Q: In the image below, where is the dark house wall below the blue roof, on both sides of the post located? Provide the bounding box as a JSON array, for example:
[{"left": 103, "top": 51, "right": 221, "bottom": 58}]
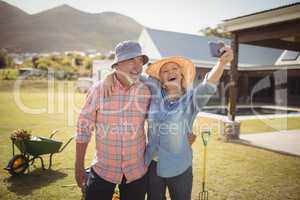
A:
[{"left": 194, "top": 68, "right": 300, "bottom": 107}]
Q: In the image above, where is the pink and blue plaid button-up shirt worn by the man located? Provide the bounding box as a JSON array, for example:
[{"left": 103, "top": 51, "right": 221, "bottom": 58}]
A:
[{"left": 76, "top": 79, "right": 151, "bottom": 184}]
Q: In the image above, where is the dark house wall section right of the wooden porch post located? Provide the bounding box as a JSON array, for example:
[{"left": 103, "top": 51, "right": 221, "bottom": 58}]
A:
[{"left": 238, "top": 69, "right": 300, "bottom": 107}]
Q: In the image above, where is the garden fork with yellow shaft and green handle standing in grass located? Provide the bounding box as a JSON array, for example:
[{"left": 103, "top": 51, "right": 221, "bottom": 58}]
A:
[{"left": 199, "top": 130, "right": 210, "bottom": 200}]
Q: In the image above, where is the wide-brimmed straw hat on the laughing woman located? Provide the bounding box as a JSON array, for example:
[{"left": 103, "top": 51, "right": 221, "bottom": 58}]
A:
[{"left": 146, "top": 56, "right": 196, "bottom": 88}]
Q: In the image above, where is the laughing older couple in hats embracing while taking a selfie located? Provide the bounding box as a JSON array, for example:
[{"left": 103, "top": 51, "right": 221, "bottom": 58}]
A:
[{"left": 75, "top": 41, "right": 233, "bottom": 200}]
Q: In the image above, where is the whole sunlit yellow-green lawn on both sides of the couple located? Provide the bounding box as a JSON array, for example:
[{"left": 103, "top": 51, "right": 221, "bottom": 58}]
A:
[{"left": 0, "top": 81, "right": 300, "bottom": 200}]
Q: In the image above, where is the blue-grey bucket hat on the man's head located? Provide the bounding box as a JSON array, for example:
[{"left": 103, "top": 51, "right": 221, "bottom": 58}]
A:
[{"left": 111, "top": 41, "right": 149, "bottom": 68}]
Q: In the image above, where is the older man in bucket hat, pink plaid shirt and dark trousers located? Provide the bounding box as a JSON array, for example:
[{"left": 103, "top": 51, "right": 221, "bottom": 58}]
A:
[{"left": 75, "top": 41, "right": 151, "bottom": 200}]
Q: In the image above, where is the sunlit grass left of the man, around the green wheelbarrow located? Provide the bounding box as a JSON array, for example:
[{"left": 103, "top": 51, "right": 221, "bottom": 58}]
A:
[{"left": 0, "top": 81, "right": 93, "bottom": 199}]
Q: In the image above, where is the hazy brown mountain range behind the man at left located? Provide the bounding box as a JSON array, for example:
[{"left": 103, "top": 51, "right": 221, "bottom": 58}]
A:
[{"left": 0, "top": 1, "right": 143, "bottom": 52}]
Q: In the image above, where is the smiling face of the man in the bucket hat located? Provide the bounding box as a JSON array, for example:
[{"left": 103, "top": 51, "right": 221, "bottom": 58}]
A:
[{"left": 116, "top": 56, "right": 143, "bottom": 82}]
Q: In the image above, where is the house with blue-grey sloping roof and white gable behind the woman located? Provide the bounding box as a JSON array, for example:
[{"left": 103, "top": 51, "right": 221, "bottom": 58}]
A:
[{"left": 139, "top": 28, "right": 300, "bottom": 105}]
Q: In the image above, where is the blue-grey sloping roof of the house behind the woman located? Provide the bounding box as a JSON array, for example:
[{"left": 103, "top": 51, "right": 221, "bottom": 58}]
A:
[{"left": 145, "top": 28, "right": 283, "bottom": 67}]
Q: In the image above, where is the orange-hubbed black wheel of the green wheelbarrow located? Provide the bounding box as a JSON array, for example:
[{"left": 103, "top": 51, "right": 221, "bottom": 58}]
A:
[{"left": 6, "top": 154, "right": 29, "bottom": 175}]
